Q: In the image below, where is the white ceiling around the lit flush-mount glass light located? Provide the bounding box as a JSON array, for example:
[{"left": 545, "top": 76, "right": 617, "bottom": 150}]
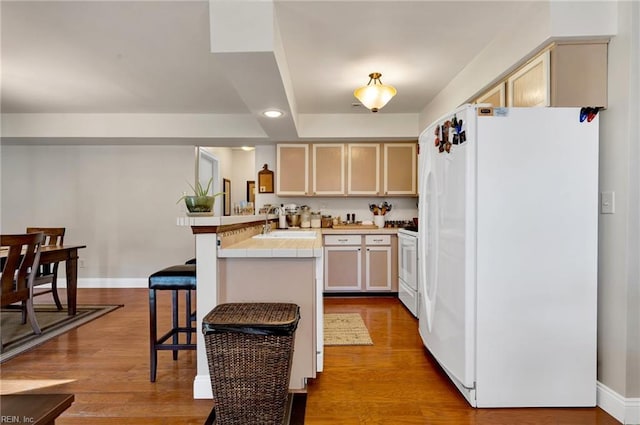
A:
[{"left": 0, "top": 0, "right": 530, "bottom": 142}]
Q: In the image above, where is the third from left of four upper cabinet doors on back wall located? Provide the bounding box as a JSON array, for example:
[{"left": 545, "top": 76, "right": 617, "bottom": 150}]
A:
[{"left": 347, "top": 143, "right": 380, "bottom": 195}]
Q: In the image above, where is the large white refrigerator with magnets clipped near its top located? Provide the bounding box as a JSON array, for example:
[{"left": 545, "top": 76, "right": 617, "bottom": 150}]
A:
[{"left": 418, "top": 105, "right": 598, "bottom": 407}]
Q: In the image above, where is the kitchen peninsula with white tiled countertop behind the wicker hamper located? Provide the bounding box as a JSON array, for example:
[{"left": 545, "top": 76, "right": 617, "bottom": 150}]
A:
[{"left": 185, "top": 215, "right": 323, "bottom": 398}]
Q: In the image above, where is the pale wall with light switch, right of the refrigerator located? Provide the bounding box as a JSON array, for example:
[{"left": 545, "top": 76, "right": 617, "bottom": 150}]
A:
[{"left": 598, "top": 2, "right": 640, "bottom": 408}]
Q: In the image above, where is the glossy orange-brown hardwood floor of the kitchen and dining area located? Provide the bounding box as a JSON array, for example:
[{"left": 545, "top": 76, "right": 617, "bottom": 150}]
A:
[{"left": 0, "top": 289, "right": 618, "bottom": 425}]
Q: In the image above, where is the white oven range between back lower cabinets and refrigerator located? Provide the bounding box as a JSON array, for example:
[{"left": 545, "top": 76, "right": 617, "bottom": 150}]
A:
[{"left": 398, "top": 229, "right": 418, "bottom": 317}]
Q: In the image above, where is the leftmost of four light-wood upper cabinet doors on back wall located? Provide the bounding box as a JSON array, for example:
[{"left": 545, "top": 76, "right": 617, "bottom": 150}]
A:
[{"left": 276, "top": 144, "right": 309, "bottom": 196}]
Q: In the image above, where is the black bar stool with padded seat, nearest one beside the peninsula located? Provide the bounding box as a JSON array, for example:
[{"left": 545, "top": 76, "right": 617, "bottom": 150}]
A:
[{"left": 149, "top": 264, "right": 196, "bottom": 382}]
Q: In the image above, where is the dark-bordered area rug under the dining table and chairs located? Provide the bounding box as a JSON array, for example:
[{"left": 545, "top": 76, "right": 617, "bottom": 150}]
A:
[{"left": 0, "top": 305, "right": 122, "bottom": 363}]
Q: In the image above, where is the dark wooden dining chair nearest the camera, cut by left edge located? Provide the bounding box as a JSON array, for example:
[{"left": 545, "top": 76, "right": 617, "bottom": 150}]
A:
[{"left": 0, "top": 233, "right": 44, "bottom": 335}]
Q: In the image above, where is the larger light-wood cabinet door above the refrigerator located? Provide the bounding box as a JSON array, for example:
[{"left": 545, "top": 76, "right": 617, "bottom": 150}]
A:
[{"left": 507, "top": 50, "right": 551, "bottom": 107}]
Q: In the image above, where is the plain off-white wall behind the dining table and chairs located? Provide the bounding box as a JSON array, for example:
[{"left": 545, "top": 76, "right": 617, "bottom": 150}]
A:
[{"left": 0, "top": 145, "right": 195, "bottom": 286}]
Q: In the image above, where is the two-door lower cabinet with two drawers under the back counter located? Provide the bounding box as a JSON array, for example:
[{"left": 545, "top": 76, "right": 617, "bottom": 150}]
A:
[{"left": 324, "top": 234, "right": 397, "bottom": 292}]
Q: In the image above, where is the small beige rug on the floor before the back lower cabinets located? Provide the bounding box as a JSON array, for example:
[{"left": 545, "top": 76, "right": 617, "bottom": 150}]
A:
[{"left": 324, "top": 313, "right": 373, "bottom": 345}]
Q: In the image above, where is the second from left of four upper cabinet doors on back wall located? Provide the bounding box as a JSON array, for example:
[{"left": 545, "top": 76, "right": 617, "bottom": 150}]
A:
[{"left": 311, "top": 143, "right": 345, "bottom": 195}]
